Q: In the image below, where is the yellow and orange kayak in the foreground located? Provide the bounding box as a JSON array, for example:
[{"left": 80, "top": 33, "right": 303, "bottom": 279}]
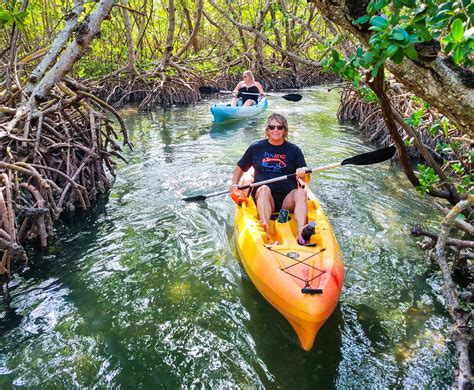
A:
[{"left": 234, "top": 173, "right": 344, "bottom": 351}]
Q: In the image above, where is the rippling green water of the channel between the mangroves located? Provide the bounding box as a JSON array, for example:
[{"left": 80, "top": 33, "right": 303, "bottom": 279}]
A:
[{"left": 0, "top": 88, "right": 454, "bottom": 389}]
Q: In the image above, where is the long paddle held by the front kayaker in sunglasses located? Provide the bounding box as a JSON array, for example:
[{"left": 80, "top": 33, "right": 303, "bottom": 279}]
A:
[{"left": 183, "top": 145, "right": 396, "bottom": 202}]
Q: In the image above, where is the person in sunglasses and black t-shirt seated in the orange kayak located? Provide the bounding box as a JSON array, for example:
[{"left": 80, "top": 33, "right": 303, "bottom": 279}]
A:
[{"left": 230, "top": 113, "right": 308, "bottom": 244}]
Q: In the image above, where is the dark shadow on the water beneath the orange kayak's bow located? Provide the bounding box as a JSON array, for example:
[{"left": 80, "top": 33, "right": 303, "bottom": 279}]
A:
[{"left": 240, "top": 270, "right": 343, "bottom": 389}]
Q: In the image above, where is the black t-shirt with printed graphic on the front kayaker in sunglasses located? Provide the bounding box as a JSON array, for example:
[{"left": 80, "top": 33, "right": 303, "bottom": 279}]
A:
[{"left": 237, "top": 139, "right": 306, "bottom": 195}]
